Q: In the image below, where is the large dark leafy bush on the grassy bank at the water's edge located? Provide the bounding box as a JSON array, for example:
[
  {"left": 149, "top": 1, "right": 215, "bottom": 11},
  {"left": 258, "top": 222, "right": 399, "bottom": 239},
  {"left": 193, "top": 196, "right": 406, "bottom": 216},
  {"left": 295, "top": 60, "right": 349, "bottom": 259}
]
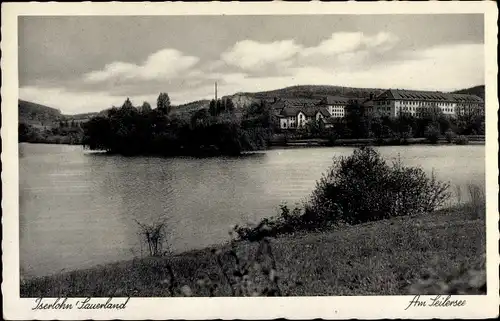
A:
[{"left": 304, "top": 147, "right": 449, "bottom": 225}]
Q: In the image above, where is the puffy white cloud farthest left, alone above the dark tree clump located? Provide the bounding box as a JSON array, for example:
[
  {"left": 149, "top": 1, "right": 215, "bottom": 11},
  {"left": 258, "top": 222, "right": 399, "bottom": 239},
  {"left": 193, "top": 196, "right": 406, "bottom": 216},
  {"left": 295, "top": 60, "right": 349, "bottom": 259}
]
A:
[{"left": 84, "top": 49, "right": 199, "bottom": 83}]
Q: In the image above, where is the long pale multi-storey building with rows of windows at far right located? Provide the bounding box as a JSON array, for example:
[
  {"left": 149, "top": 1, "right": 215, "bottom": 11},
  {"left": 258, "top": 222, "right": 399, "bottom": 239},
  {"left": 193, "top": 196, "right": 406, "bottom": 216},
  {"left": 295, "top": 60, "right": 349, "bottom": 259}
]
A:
[{"left": 373, "top": 89, "right": 484, "bottom": 117}]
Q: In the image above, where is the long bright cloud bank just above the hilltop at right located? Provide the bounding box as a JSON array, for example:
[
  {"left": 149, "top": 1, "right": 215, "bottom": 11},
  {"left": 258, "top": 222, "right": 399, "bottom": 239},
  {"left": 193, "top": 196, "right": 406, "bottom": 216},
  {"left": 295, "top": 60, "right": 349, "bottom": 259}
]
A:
[{"left": 284, "top": 44, "right": 484, "bottom": 91}]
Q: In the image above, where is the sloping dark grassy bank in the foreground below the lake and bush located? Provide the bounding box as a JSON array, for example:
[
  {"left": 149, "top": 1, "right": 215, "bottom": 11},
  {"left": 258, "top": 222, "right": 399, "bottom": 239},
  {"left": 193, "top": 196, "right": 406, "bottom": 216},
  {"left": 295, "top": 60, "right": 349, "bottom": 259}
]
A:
[{"left": 21, "top": 206, "right": 486, "bottom": 297}]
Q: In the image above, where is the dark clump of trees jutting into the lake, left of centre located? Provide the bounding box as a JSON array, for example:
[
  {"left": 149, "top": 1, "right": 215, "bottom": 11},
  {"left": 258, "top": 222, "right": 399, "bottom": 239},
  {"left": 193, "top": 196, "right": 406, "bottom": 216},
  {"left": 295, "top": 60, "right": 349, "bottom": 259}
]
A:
[{"left": 83, "top": 93, "right": 272, "bottom": 156}]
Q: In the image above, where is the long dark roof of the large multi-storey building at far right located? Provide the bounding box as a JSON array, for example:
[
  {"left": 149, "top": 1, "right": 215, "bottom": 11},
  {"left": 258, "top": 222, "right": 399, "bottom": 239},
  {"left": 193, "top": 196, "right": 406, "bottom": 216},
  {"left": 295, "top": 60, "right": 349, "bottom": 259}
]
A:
[{"left": 374, "top": 89, "right": 482, "bottom": 102}]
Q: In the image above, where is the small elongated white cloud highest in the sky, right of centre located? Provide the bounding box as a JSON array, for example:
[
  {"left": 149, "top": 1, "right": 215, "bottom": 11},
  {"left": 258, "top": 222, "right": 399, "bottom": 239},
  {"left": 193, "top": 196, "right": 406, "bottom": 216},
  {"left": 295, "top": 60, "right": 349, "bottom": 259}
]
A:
[{"left": 301, "top": 32, "right": 398, "bottom": 57}]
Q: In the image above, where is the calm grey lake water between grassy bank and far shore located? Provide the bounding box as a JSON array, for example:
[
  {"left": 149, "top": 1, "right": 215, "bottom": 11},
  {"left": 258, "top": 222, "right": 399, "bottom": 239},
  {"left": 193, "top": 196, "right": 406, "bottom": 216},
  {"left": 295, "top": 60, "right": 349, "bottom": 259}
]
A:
[{"left": 19, "top": 144, "right": 485, "bottom": 277}]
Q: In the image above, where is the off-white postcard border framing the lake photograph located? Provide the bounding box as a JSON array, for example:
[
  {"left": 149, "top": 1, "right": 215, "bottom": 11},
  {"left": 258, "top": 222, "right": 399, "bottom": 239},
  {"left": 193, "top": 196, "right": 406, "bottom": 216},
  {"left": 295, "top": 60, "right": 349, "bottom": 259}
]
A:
[{"left": 1, "top": 1, "right": 499, "bottom": 320}]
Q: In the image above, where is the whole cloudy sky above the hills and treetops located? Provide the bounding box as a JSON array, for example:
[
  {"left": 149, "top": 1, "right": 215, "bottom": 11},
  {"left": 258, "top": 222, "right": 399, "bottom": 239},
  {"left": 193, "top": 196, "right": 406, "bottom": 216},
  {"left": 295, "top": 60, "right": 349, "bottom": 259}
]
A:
[{"left": 18, "top": 14, "right": 485, "bottom": 114}]
